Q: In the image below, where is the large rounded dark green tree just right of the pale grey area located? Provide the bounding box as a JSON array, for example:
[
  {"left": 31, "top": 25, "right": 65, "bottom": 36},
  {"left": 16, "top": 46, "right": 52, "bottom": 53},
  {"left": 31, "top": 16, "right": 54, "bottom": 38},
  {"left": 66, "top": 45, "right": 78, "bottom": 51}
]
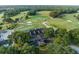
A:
[{"left": 10, "top": 31, "right": 31, "bottom": 44}]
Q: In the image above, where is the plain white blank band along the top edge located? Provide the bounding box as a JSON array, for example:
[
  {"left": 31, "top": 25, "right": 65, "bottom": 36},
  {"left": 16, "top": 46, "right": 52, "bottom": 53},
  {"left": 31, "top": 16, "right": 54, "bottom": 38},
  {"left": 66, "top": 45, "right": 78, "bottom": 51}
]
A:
[{"left": 0, "top": 0, "right": 79, "bottom": 5}]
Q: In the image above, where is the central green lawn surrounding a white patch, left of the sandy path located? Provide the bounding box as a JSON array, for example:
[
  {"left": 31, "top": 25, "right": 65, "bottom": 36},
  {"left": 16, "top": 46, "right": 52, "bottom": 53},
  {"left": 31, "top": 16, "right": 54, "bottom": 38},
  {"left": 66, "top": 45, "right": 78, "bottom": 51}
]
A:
[{"left": 15, "top": 16, "right": 48, "bottom": 31}]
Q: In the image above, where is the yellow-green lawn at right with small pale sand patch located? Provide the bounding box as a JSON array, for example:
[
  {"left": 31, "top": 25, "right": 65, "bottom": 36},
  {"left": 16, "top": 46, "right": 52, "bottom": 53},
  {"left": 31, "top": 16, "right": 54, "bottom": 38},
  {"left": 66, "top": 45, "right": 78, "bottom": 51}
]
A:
[{"left": 49, "top": 13, "right": 79, "bottom": 30}]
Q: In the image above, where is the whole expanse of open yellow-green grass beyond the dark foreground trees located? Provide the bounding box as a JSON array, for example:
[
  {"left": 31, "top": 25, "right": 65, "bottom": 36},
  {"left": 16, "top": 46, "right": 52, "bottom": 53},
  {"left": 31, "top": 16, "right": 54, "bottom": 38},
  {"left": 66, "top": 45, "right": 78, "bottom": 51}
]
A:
[{"left": 9, "top": 11, "right": 79, "bottom": 31}]
